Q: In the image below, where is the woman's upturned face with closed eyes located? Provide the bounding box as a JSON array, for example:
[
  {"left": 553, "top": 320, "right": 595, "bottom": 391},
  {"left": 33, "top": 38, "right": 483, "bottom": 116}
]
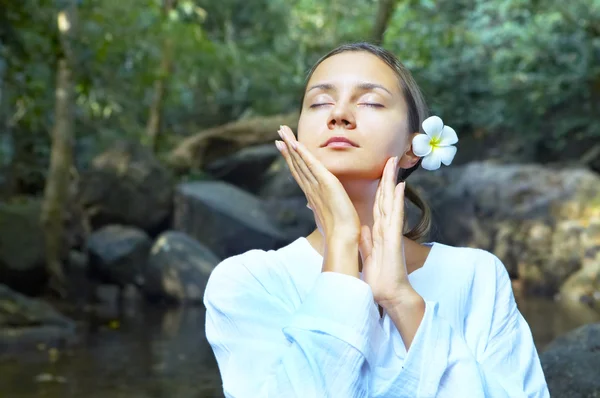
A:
[{"left": 298, "top": 52, "right": 416, "bottom": 179}]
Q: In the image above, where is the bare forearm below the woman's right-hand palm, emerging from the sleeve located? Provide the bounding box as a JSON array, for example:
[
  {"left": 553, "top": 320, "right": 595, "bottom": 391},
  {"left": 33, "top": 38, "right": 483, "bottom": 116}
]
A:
[{"left": 384, "top": 289, "right": 425, "bottom": 351}]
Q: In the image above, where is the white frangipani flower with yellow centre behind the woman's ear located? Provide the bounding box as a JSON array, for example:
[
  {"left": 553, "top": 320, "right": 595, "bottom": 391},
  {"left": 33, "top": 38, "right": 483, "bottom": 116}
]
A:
[{"left": 412, "top": 116, "right": 458, "bottom": 170}]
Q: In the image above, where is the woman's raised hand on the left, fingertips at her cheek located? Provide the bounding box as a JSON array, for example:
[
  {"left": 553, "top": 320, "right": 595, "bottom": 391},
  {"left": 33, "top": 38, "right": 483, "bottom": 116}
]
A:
[{"left": 275, "top": 126, "right": 360, "bottom": 244}]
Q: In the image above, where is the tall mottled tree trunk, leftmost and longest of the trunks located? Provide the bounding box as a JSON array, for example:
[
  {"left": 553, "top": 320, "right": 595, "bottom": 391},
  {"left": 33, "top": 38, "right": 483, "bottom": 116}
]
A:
[{"left": 41, "top": 3, "right": 75, "bottom": 296}]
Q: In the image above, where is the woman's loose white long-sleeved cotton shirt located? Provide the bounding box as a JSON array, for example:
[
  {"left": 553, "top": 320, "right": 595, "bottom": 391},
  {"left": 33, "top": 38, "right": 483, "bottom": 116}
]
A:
[{"left": 204, "top": 238, "right": 549, "bottom": 398}]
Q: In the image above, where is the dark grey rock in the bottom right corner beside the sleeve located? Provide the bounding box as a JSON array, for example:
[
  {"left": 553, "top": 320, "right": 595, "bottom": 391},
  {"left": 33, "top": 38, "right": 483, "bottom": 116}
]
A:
[{"left": 540, "top": 323, "right": 600, "bottom": 398}]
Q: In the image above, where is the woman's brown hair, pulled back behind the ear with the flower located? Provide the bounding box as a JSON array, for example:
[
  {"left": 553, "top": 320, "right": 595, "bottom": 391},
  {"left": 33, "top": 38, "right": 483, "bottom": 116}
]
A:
[{"left": 300, "top": 42, "right": 431, "bottom": 241}]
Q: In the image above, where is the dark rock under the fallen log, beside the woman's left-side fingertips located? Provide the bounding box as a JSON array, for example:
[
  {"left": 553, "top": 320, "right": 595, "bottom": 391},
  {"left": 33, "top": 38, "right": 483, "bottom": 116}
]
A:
[{"left": 205, "top": 144, "right": 281, "bottom": 194}]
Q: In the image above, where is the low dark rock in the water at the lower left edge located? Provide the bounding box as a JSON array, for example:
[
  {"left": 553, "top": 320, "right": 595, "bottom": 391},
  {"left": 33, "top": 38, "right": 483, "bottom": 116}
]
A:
[{"left": 0, "top": 285, "right": 76, "bottom": 358}]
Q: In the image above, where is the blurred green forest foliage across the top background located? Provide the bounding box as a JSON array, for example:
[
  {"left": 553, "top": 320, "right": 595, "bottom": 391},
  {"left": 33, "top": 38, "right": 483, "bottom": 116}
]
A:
[{"left": 0, "top": 0, "right": 600, "bottom": 193}]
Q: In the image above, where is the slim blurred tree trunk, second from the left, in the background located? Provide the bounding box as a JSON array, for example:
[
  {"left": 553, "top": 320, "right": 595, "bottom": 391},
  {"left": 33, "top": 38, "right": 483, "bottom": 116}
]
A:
[{"left": 146, "top": 0, "right": 177, "bottom": 152}]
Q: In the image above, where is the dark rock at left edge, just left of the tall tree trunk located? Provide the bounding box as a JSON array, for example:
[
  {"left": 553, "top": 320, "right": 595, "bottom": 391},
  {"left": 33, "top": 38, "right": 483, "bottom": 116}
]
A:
[{"left": 0, "top": 200, "right": 47, "bottom": 295}]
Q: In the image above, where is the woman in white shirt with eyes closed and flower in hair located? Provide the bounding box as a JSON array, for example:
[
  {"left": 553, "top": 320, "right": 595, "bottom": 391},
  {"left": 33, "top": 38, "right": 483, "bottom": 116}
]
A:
[{"left": 204, "top": 43, "right": 549, "bottom": 398}]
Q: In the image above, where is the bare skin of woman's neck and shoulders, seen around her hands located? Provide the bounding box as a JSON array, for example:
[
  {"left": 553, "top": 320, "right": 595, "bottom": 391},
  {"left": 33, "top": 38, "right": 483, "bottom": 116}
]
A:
[{"left": 307, "top": 180, "right": 431, "bottom": 273}]
